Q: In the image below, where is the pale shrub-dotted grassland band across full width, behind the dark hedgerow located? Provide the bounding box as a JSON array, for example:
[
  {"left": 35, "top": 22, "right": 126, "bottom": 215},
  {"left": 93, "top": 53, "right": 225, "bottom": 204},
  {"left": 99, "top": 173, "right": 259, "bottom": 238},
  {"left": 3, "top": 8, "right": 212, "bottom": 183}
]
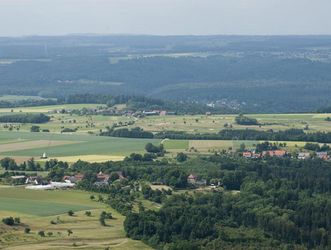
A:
[{"left": 0, "top": 104, "right": 331, "bottom": 134}]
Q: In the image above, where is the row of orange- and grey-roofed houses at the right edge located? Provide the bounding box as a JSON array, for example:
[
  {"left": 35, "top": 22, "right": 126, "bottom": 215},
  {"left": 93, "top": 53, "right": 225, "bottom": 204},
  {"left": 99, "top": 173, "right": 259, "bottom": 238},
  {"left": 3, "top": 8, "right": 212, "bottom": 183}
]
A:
[{"left": 242, "top": 149, "right": 331, "bottom": 160}]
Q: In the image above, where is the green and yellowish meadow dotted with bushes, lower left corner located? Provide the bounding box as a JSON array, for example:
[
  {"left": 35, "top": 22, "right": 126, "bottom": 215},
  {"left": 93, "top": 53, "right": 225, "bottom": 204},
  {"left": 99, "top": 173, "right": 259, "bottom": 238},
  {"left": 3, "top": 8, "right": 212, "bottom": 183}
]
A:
[{"left": 0, "top": 186, "right": 149, "bottom": 250}]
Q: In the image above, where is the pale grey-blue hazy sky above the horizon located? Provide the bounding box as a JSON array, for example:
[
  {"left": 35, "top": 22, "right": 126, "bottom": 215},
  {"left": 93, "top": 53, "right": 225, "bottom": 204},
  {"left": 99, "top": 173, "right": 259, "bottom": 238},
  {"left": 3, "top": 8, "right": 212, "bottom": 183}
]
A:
[{"left": 0, "top": 0, "right": 331, "bottom": 36}]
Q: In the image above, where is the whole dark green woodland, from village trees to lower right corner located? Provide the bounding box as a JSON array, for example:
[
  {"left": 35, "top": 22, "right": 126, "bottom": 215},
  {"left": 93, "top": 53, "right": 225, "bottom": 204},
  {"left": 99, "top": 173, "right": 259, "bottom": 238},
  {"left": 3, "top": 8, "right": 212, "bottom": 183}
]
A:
[{"left": 35, "top": 154, "right": 331, "bottom": 249}]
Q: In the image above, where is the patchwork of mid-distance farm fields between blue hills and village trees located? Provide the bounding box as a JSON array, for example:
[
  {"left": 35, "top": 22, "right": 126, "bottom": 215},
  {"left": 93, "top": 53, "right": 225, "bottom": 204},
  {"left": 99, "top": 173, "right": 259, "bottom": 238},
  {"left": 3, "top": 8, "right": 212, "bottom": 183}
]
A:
[{"left": 0, "top": 102, "right": 331, "bottom": 162}]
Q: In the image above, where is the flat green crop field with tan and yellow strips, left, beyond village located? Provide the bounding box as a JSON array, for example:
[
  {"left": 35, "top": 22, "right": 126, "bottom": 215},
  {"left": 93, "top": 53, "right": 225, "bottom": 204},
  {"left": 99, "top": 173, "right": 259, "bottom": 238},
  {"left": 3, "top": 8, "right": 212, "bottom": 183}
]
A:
[{"left": 0, "top": 131, "right": 160, "bottom": 161}]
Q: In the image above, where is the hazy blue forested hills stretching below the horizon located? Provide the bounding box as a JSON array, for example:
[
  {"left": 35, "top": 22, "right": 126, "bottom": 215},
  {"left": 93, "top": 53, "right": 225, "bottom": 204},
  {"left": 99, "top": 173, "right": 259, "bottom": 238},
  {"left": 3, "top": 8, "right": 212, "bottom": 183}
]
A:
[{"left": 0, "top": 36, "right": 331, "bottom": 112}]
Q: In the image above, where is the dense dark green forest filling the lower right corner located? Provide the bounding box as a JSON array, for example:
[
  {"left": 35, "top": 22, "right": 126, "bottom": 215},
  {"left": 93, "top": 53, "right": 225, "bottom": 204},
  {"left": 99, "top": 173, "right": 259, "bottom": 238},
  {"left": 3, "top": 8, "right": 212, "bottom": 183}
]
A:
[{"left": 124, "top": 156, "right": 331, "bottom": 249}]
